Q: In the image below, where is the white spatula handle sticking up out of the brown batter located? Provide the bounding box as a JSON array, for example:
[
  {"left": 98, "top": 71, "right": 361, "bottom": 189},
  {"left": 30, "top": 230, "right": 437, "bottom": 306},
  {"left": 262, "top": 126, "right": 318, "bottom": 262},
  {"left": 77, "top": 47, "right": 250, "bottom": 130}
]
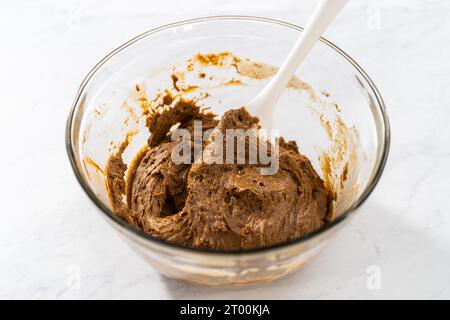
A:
[{"left": 246, "top": 0, "right": 349, "bottom": 129}]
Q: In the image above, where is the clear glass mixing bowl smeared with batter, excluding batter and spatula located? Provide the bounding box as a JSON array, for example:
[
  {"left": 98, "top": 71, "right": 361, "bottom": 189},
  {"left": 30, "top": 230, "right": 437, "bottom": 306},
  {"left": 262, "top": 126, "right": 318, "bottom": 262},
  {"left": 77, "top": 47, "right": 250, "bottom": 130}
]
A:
[{"left": 66, "top": 16, "right": 390, "bottom": 286}]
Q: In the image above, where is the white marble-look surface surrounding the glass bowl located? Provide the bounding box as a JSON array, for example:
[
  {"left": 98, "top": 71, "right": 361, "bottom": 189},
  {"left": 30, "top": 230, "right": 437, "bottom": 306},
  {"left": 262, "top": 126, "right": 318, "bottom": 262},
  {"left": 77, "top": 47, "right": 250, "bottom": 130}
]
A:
[{"left": 0, "top": 0, "right": 450, "bottom": 299}]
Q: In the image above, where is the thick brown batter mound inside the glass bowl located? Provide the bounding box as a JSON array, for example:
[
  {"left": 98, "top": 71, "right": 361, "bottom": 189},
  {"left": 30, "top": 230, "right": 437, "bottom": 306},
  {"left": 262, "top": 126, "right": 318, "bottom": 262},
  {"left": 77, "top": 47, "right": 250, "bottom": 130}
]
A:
[{"left": 106, "top": 95, "right": 330, "bottom": 250}]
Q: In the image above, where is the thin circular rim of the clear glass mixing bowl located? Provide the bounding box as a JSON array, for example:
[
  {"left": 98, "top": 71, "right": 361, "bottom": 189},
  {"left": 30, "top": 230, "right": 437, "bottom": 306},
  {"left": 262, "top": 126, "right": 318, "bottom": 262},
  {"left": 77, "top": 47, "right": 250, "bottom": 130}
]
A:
[{"left": 65, "top": 15, "right": 390, "bottom": 256}]
